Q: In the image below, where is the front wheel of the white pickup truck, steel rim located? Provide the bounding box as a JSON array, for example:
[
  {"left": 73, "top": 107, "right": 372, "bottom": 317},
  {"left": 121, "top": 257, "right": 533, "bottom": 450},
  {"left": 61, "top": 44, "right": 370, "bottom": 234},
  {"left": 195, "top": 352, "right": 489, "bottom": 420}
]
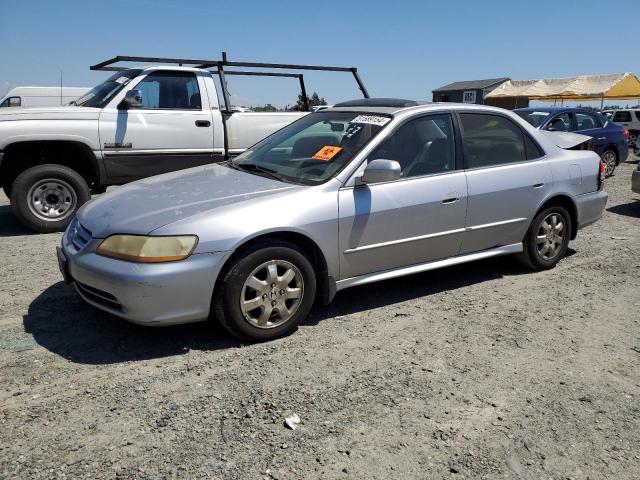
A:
[{"left": 11, "top": 164, "right": 91, "bottom": 233}]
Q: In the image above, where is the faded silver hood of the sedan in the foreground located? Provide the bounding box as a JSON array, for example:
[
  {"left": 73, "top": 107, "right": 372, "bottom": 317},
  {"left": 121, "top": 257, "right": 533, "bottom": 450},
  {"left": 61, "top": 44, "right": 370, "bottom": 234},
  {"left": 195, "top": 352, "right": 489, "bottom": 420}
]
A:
[{"left": 78, "top": 165, "right": 304, "bottom": 238}]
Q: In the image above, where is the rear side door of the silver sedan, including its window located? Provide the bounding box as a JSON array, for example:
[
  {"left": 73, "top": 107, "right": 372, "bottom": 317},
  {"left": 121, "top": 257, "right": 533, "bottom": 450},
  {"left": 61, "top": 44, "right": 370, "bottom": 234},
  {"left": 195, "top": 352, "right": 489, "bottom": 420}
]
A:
[{"left": 459, "top": 112, "right": 552, "bottom": 254}]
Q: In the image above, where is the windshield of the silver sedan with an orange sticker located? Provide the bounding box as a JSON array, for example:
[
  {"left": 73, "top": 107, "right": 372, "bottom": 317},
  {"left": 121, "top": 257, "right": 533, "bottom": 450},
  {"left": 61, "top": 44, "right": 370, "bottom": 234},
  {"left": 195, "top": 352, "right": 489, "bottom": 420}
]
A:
[{"left": 229, "top": 110, "right": 391, "bottom": 185}]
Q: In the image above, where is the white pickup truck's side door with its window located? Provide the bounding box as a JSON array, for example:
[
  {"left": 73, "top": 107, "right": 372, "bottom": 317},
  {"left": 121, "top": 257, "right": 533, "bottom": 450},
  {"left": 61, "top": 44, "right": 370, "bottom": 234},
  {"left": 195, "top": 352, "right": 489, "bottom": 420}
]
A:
[{"left": 99, "top": 70, "right": 216, "bottom": 181}]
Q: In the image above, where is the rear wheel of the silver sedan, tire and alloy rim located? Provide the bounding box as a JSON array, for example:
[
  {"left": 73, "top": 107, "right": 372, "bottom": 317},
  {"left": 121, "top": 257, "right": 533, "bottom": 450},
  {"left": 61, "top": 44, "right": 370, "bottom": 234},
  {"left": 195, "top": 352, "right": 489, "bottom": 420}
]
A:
[{"left": 517, "top": 206, "right": 571, "bottom": 271}]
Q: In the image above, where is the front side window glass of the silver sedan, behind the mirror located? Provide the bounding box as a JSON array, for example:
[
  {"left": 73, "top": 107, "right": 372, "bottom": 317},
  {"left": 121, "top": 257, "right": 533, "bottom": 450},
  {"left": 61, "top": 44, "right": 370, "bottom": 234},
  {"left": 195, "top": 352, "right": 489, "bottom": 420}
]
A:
[{"left": 369, "top": 114, "right": 455, "bottom": 178}]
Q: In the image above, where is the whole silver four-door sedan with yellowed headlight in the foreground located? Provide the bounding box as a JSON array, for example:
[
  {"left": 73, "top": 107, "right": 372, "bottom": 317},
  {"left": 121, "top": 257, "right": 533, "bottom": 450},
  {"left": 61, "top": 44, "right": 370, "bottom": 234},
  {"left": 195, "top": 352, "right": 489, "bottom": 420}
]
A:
[{"left": 58, "top": 99, "right": 607, "bottom": 340}]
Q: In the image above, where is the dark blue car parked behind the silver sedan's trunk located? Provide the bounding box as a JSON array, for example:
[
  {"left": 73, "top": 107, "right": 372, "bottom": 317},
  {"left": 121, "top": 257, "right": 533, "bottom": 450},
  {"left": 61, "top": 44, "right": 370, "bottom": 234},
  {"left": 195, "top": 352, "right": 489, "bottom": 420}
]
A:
[{"left": 514, "top": 107, "right": 629, "bottom": 176}]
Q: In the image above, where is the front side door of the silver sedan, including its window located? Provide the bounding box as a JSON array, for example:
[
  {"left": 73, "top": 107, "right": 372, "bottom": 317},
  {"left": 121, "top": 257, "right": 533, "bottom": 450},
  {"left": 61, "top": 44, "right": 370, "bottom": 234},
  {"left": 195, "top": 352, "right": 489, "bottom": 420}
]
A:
[{"left": 339, "top": 114, "right": 467, "bottom": 279}]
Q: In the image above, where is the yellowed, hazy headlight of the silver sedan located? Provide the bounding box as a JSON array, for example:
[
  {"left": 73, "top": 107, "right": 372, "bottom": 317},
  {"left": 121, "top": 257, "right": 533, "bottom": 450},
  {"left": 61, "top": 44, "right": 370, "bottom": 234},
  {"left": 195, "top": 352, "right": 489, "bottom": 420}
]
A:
[{"left": 96, "top": 235, "right": 198, "bottom": 263}]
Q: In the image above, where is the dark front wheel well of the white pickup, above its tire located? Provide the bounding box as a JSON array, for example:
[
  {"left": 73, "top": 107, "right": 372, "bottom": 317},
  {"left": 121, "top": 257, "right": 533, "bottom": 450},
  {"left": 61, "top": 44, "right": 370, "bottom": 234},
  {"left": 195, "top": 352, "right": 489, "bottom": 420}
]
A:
[{"left": 0, "top": 140, "right": 100, "bottom": 187}]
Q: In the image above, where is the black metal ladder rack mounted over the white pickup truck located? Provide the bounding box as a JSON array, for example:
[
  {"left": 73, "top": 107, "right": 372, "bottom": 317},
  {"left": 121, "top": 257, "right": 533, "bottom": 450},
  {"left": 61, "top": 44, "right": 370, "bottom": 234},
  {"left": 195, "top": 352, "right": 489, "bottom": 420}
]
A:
[{"left": 89, "top": 52, "right": 369, "bottom": 111}]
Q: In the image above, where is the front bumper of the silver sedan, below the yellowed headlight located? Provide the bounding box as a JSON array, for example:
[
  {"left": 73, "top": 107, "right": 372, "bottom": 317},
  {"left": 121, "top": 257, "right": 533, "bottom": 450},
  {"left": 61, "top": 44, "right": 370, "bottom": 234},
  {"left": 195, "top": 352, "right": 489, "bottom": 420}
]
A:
[{"left": 58, "top": 228, "right": 231, "bottom": 326}]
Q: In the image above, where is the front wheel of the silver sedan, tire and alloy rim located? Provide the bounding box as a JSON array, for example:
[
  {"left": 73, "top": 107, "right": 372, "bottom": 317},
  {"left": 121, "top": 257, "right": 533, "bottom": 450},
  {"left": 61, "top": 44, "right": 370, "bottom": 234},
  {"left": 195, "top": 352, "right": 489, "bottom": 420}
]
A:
[{"left": 212, "top": 240, "right": 316, "bottom": 342}]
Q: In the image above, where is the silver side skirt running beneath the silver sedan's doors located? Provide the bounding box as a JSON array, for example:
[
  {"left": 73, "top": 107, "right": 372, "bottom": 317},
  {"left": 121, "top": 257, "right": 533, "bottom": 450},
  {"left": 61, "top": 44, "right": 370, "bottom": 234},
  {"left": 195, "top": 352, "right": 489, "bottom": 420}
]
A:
[{"left": 336, "top": 243, "right": 523, "bottom": 291}]
